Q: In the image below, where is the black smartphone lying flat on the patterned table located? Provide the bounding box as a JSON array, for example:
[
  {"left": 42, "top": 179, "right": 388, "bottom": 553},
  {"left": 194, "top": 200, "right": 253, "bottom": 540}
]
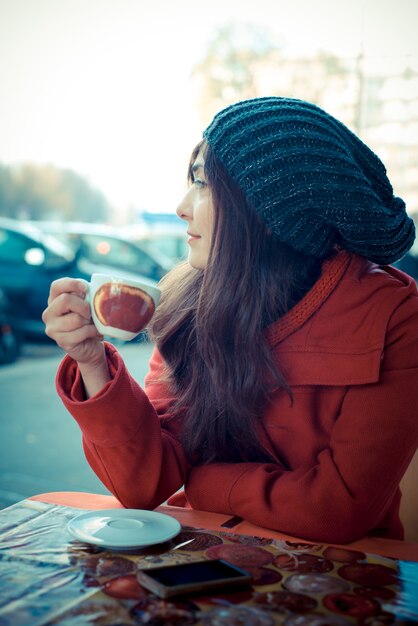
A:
[{"left": 136, "top": 559, "right": 251, "bottom": 598}]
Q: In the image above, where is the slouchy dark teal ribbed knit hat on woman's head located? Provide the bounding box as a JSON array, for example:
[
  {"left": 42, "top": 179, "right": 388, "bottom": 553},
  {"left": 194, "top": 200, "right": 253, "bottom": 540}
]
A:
[{"left": 203, "top": 97, "right": 415, "bottom": 264}]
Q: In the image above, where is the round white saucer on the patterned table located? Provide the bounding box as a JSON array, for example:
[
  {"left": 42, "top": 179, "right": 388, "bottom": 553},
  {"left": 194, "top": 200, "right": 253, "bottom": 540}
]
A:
[{"left": 67, "top": 509, "right": 181, "bottom": 550}]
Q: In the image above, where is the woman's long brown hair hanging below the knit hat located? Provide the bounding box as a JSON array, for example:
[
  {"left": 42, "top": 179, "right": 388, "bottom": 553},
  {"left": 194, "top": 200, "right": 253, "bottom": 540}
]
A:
[{"left": 149, "top": 142, "right": 321, "bottom": 464}]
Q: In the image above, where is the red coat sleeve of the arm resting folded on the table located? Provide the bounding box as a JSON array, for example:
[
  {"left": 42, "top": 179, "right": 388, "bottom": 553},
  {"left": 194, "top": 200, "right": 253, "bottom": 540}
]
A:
[{"left": 186, "top": 297, "right": 418, "bottom": 543}]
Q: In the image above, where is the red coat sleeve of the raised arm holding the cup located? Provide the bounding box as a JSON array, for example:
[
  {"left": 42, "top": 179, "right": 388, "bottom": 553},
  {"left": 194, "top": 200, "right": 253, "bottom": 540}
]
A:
[{"left": 57, "top": 344, "right": 188, "bottom": 509}]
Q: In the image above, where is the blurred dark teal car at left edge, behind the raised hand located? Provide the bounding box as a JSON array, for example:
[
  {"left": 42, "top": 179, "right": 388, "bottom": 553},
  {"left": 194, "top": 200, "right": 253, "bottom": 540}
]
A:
[{"left": 0, "top": 218, "right": 156, "bottom": 339}]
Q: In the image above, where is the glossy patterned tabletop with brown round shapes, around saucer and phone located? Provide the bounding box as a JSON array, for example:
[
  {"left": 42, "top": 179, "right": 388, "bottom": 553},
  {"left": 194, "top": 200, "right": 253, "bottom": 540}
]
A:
[{"left": 0, "top": 492, "right": 418, "bottom": 626}]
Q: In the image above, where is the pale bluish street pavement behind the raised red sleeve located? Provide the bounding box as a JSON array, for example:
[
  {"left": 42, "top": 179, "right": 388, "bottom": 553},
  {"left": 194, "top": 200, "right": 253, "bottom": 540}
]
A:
[{"left": 0, "top": 336, "right": 152, "bottom": 508}]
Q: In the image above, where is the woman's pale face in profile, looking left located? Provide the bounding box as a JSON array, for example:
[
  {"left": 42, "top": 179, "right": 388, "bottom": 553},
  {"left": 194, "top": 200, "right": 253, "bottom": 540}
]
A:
[{"left": 176, "top": 151, "right": 214, "bottom": 269}]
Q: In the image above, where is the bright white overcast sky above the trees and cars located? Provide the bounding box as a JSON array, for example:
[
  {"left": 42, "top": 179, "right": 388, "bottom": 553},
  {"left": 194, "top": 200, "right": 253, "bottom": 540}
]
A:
[{"left": 0, "top": 0, "right": 418, "bottom": 216}]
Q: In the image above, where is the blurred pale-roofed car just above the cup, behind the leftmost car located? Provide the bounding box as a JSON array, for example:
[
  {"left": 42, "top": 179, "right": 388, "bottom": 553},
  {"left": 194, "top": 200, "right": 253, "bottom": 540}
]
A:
[{"left": 31, "top": 221, "right": 173, "bottom": 282}]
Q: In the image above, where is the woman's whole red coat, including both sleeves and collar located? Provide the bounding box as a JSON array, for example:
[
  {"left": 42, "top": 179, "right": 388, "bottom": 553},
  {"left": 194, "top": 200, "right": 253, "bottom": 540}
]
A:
[{"left": 57, "top": 252, "right": 418, "bottom": 543}]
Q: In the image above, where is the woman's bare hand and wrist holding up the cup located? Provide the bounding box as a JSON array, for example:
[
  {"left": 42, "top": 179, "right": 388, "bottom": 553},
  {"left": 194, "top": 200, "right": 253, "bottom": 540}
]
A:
[{"left": 42, "top": 278, "right": 110, "bottom": 397}]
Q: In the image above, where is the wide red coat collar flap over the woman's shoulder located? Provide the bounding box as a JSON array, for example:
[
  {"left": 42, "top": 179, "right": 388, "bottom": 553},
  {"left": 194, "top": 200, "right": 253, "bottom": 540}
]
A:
[{"left": 266, "top": 246, "right": 415, "bottom": 386}]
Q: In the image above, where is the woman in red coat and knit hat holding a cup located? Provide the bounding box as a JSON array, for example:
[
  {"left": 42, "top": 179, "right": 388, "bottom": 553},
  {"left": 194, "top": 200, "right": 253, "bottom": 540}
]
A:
[{"left": 43, "top": 97, "right": 418, "bottom": 543}]
